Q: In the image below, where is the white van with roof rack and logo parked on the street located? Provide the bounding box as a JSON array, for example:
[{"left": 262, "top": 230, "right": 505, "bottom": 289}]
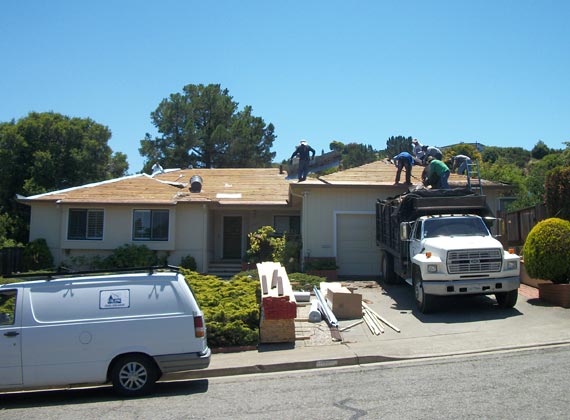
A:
[{"left": 0, "top": 271, "right": 211, "bottom": 396}]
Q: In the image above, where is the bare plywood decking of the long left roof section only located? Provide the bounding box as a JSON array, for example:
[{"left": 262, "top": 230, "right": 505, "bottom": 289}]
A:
[{"left": 22, "top": 168, "right": 290, "bottom": 205}]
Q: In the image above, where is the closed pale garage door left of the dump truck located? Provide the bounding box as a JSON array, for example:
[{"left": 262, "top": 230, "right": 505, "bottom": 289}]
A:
[{"left": 337, "top": 214, "right": 380, "bottom": 276}]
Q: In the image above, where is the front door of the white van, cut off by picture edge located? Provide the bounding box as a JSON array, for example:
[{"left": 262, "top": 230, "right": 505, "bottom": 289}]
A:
[{"left": 0, "top": 290, "right": 22, "bottom": 386}]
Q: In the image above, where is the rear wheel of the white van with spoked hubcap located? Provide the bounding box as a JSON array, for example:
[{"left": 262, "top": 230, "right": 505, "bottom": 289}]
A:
[{"left": 111, "top": 355, "right": 158, "bottom": 397}]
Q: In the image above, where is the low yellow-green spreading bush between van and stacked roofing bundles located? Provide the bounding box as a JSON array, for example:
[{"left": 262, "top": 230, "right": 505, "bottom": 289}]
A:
[{"left": 182, "top": 270, "right": 260, "bottom": 348}]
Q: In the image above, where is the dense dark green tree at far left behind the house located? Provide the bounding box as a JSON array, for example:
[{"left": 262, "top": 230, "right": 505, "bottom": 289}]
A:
[{"left": 0, "top": 112, "right": 128, "bottom": 242}]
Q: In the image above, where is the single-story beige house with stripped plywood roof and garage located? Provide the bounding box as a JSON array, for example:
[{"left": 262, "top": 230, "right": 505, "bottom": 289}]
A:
[{"left": 19, "top": 161, "right": 510, "bottom": 276}]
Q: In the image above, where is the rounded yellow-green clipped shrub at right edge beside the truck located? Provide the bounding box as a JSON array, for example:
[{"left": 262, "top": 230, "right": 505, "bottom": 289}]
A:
[{"left": 523, "top": 218, "right": 570, "bottom": 283}]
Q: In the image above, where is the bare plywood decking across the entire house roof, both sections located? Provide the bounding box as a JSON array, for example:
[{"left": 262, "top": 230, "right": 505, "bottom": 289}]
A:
[{"left": 20, "top": 161, "right": 504, "bottom": 206}]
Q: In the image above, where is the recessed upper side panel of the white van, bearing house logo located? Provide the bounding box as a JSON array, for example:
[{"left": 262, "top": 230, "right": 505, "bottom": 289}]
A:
[{"left": 30, "top": 279, "right": 184, "bottom": 323}]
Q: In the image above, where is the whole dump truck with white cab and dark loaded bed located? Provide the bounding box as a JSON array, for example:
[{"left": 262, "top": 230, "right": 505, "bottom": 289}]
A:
[{"left": 376, "top": 189, "right": 520, "bottom": 313}]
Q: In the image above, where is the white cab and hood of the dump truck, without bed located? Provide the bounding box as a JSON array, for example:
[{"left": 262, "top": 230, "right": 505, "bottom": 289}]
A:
[{"left": 404, "top": 214, "right": 520, "bottom": 310}]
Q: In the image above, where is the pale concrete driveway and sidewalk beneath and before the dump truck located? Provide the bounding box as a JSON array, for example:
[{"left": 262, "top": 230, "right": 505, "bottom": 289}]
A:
[{"left": 162, "top": 282, "right": 570, "bottom": 379}]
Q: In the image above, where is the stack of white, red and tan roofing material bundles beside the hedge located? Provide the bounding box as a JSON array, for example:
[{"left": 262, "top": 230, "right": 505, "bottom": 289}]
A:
[{"left": 257, "top": 262, "right": 297, "bottom": 343}]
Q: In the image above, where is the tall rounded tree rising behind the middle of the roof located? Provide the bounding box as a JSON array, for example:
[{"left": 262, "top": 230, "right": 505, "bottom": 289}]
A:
[{"left": 139, "top": 84, "right": 276, "bottom": 172}]
